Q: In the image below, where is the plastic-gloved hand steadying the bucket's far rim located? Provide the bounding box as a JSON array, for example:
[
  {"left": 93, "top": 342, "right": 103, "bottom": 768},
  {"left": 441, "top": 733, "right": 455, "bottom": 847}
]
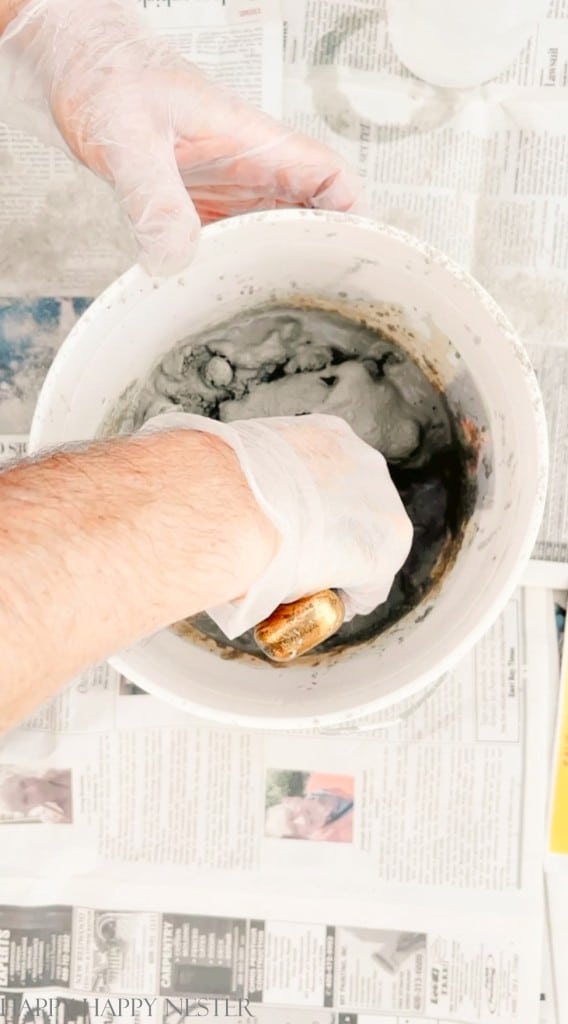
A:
[{"left": 0, "top": 0, "right": 360, "bottom": 273}]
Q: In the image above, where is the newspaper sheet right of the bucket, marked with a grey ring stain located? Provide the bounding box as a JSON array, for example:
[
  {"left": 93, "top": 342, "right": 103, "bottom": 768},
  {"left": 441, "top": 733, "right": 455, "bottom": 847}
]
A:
[{"left": 283, "top": 0, "right": 568, "bottom": 562}]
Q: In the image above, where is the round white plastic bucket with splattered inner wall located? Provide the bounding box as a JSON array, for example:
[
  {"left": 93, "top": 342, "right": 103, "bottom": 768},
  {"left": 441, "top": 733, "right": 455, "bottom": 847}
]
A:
[{"left": 31, "top": 210, "right": 547, "bottom": 729}]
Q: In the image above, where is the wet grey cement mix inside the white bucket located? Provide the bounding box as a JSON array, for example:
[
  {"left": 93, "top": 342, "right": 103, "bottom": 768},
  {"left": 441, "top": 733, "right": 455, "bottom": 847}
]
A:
[{"left": 108, "top": 307, "right": 472, "bottom": 656}]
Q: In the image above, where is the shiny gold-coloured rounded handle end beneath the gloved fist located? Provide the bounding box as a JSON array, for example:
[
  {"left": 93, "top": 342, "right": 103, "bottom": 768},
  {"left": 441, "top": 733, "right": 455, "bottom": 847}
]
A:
[{"left": 255, "top": 590, "right": 345, "bottom": 662}]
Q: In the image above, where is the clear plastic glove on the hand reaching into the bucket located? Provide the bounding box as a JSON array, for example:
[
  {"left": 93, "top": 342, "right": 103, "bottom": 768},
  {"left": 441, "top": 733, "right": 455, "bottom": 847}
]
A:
[{"left": 142, "top": 413, "right": 412, "bottom": 639}]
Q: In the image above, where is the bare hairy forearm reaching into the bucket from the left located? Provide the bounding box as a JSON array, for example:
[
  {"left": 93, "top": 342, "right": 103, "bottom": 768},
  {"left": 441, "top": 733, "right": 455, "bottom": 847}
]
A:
[{"left": 0, "top": 431, "right": 277, "bottom": 729}]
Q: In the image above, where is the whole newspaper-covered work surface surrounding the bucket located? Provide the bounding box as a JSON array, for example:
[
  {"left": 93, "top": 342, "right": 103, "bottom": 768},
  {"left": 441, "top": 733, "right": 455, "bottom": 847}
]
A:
[{"left": 0, "top": 0, "right": 568, "bottom": 1024}]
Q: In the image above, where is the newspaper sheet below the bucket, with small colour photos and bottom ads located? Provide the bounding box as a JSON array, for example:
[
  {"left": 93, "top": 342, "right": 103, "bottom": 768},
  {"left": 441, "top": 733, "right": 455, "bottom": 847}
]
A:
[{"left": 0, "top": 589, "right": 557, "bottom": 1024}]
